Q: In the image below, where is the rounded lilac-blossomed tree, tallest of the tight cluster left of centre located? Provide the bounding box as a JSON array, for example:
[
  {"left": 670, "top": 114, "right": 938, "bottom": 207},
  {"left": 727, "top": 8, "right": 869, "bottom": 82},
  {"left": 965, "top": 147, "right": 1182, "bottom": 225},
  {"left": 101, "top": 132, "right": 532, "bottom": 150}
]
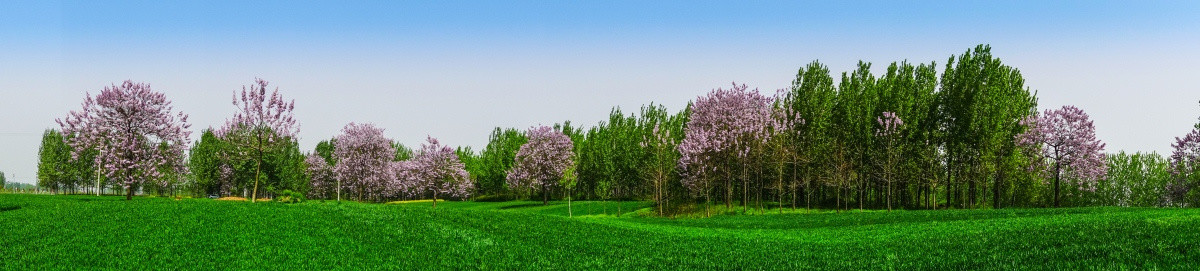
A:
[{"left": 334, "top": 122, "right": 396, "bottom": 201}]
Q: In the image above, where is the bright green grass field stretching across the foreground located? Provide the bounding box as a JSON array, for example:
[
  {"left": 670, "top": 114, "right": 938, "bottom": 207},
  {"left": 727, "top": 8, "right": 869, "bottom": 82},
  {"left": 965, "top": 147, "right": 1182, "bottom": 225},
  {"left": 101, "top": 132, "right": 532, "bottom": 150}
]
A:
[{"left": 0, "top": 194, "right": 1200, "bottom": 270}]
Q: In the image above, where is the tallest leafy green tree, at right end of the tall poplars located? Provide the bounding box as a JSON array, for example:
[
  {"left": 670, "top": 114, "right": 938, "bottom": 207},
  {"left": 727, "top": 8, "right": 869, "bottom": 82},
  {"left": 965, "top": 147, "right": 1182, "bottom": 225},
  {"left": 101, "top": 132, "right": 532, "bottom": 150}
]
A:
[{"left": 936, "top": 44, "right": 1037, "bottom": 207}]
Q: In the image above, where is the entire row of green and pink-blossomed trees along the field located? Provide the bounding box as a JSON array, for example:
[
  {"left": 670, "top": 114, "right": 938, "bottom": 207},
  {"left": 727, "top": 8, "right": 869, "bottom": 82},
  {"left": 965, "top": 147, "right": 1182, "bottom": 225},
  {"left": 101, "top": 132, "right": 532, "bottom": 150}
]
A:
[{"left": 38, "top": 46, "right": 1200, "bottom": 215}]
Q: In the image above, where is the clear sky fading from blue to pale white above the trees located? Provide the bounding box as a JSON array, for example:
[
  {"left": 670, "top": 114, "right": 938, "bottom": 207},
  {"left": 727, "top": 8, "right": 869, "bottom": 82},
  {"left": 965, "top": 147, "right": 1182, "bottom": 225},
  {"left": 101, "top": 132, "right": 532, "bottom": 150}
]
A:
[{"left": 0, "top": 0, "right": 1200, "bottom": 183}]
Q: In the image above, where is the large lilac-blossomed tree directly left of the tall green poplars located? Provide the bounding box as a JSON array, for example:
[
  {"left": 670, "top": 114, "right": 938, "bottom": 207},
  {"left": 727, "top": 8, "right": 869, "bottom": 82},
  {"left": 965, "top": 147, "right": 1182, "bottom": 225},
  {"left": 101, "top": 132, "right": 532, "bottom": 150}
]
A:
[{"left": 679, "top": 84, "right": 772, "bottom": 212}]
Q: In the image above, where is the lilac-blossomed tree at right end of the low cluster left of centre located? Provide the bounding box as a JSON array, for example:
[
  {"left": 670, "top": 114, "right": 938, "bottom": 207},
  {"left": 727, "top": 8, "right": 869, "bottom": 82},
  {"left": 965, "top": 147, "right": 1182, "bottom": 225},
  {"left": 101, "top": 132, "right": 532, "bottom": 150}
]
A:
[{"left": 410, "top": 137, "right": 475, "bottom": 207}]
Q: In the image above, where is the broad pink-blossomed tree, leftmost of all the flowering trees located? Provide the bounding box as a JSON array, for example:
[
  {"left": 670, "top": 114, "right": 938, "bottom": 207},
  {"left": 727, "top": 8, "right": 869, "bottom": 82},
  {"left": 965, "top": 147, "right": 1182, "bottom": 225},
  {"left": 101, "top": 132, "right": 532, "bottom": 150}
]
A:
[{"left": 55, "top": 80, "right": 191, "bottom": 199}]
